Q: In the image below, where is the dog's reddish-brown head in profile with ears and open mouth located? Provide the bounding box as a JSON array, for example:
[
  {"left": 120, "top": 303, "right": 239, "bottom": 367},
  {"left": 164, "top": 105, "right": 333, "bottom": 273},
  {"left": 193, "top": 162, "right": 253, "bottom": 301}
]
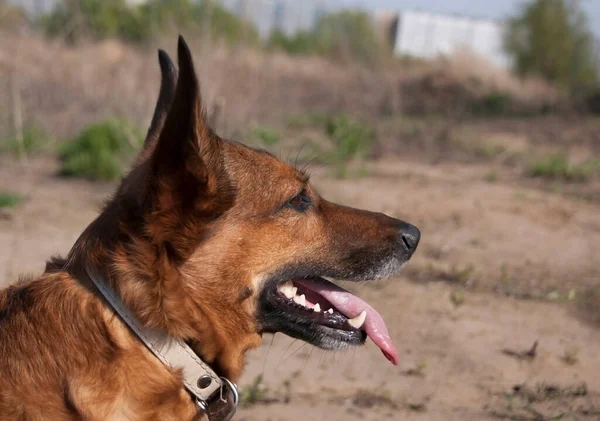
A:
[{"left": 75, "top": 38, "right": 420, "bottom": 378}]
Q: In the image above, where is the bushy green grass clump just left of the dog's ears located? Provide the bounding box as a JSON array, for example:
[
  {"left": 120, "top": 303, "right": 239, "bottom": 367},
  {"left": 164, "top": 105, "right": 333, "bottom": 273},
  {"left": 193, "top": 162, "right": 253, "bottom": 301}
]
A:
[{"left": 59, "top": 119, "right": 143, "bottom": 181}]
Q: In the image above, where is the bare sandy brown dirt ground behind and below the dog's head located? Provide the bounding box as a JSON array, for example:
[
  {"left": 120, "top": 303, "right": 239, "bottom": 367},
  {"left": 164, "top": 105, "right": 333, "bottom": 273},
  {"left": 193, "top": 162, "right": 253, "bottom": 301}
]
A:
[{"left": 0, "top": 151, "right": 600, "bottom": 421}]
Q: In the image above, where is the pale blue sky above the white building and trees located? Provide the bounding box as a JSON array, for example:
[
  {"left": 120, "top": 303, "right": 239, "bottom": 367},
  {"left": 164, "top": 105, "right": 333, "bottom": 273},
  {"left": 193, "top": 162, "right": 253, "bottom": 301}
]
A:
[{"left": 329, "top": 0, "right": 600, "bottom": 37}]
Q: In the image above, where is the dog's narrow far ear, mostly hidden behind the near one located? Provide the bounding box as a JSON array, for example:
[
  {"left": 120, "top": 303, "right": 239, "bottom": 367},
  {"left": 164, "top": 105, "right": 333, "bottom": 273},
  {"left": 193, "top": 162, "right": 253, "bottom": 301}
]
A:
[{"left": 144, "top": 50, "right": 177, "bottom": 148}]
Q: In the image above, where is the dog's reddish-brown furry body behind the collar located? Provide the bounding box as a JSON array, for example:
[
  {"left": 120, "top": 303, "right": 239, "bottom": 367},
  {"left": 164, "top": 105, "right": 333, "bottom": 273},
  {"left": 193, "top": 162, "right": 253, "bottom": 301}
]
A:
[{"left": 0, "top": 262, "right": 202, "bottom": 421}]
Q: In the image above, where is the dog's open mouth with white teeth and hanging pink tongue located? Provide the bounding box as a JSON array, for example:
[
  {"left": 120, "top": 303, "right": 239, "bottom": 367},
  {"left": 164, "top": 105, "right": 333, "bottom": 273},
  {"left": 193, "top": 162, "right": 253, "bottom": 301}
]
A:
[{"left": 262, "top": 277, "right": 399, "bottom": 365}]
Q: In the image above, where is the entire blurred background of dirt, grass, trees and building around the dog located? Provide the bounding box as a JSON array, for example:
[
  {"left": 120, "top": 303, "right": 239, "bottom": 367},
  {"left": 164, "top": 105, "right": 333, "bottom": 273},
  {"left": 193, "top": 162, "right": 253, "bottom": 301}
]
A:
[{"left": 0, "top": 0, "right": 600, "bottom": 421}]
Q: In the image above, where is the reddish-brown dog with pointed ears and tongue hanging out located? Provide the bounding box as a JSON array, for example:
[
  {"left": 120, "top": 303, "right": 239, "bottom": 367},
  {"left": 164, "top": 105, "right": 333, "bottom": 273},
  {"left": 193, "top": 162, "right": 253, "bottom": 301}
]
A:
[{"left": 0, "top": 38, "right": 420, "bottom": 421}]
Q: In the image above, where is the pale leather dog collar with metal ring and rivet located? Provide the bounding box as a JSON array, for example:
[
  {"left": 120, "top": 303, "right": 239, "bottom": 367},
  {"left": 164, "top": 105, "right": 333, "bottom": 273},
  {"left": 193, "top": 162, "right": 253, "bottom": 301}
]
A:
[{"left": 85, "top": 266, "right": 239, "bottom": 421}]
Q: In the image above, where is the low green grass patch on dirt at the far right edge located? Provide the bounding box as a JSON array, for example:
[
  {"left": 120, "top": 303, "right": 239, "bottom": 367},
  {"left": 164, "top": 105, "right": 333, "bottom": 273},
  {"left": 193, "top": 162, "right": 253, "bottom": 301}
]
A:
[{"left": 527, "top": 154, "right": 600, "bottom": 182}]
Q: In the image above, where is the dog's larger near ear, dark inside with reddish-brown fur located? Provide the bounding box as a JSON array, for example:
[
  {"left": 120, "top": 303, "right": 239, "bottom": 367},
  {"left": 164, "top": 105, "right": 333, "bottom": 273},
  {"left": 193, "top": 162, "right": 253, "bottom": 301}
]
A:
[{"left": 145, "top": 36, "right": 233, "bottom": 261}]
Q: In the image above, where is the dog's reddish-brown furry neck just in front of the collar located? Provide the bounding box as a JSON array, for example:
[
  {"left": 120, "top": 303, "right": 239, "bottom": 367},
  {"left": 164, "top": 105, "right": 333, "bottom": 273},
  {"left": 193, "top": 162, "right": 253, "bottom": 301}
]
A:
[{"left": 67, "top": 194, "right": 261, "bottom": 381}]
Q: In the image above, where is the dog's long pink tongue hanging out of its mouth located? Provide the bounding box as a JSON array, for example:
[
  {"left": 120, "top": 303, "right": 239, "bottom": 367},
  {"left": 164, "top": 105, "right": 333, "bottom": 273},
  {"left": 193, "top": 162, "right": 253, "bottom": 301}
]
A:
[{"left": 294, "top": 279, "right": 400, "bottom": 365}]
